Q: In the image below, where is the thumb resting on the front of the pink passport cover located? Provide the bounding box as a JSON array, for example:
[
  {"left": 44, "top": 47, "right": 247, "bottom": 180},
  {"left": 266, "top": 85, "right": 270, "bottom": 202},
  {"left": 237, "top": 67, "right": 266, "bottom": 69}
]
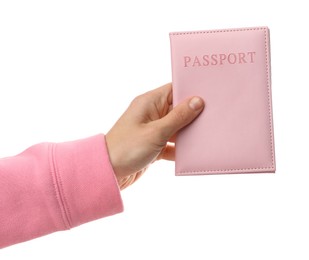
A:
[{"left": 158, "top": 97, "right": 205, "bottom": 140}]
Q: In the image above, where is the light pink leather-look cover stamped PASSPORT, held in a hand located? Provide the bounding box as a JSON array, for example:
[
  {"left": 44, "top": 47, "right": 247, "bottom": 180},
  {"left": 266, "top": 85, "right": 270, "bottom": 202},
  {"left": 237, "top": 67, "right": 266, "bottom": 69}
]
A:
[{"left": 170, "top": 27, "right": 275, "bottom": 175}]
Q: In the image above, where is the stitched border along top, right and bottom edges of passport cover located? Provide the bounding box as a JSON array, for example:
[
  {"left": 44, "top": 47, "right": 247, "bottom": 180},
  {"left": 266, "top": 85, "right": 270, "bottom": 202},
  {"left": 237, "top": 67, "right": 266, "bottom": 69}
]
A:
[{"left": 170, "top": 27, "right": 274, "bottom": 174}]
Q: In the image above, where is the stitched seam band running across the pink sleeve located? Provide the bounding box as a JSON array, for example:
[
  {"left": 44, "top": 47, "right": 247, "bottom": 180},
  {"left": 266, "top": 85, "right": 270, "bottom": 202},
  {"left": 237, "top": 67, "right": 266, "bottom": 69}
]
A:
[{"left": 50, "top": 144, "right": 71, "bottom": 229}]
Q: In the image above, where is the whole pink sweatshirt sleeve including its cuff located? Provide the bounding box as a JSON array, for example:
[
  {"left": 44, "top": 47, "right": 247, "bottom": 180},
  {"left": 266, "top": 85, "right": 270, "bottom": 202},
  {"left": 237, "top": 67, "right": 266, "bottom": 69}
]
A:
[{"left": 0, "top": 135, "right": 123, "bottom": 248}]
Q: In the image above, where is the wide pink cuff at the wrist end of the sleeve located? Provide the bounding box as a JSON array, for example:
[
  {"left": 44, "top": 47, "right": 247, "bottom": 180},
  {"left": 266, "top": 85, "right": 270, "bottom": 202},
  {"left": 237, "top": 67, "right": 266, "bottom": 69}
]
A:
[{"left": 50, "top": 134, "right": 123, "bottom": 229}]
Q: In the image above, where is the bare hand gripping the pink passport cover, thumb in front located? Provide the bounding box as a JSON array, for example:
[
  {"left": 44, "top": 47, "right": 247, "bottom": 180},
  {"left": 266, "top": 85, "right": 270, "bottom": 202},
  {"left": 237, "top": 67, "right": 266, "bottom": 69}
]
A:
[{"left": 106, "top": 84, "right": 204, "bottom": 189}]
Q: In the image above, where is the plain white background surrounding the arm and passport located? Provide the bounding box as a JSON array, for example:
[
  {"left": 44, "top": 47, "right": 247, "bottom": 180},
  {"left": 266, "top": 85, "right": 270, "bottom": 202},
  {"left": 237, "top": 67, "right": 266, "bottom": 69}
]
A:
[{"left": 0, "top": 0, "right": 309, "bottom": 260}]
